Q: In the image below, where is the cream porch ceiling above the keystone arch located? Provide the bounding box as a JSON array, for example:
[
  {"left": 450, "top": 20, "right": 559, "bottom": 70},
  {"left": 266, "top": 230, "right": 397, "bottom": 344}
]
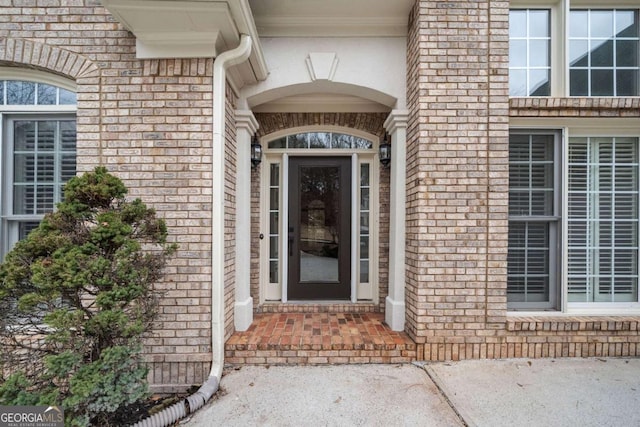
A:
[{"left": 249, "top": 0, "right": 415, "bottom": 37}]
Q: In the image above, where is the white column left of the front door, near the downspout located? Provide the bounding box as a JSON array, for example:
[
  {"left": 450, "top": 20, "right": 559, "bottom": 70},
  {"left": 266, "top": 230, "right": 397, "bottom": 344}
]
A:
[{"left": 233, "top": 110, "right": 258, "bottom": 331}]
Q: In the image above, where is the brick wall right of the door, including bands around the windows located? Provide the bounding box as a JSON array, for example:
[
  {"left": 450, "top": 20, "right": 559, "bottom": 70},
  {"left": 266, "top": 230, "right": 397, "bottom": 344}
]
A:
[{"left": 406, "top": 0, "right": 640, "bottom": 360}]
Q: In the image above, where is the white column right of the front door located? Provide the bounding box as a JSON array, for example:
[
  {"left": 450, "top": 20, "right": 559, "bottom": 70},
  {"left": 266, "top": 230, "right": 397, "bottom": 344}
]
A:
[{"left": 384, "top": 110, "right": 409, "bottom": 331}]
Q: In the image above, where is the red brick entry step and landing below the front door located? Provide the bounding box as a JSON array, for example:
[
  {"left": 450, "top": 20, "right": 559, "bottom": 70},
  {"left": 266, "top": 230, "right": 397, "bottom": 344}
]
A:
[{"left": 225, "top": 313, "right": 416, "bottom": 365}]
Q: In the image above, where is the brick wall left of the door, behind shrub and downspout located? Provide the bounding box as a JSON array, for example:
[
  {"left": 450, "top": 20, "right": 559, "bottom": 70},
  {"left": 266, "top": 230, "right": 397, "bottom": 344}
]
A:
[{"left": 0, "top": 0, "right": 226, "bottom": 390}]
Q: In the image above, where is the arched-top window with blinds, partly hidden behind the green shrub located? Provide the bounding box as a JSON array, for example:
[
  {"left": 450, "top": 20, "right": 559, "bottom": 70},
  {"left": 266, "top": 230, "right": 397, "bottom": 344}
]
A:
[{"left": 0, "top": 80, "right": 76, "bottom": 258}]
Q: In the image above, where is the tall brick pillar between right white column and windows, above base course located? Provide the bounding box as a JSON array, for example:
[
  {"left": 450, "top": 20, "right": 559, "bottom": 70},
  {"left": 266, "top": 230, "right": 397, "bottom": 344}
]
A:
[{"left": 406, "top": 0, "right": 508, "bottom": 343}]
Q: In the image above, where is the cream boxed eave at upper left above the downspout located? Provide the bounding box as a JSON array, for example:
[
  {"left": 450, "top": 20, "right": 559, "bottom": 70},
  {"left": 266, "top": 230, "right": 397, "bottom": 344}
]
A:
[{"left": 102, "top": 0, "right": 268, "bottom": 87}]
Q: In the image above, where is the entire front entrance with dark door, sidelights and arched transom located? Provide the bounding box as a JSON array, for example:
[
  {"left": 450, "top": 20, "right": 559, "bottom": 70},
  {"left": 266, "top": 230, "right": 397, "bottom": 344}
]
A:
[{"left": 260, "top": 126, "right": 380, "bottom": 303}]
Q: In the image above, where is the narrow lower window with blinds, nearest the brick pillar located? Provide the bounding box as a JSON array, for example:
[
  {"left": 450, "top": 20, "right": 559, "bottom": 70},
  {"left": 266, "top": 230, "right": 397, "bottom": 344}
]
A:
[{"left": 507, "top": 132, "right": 560, "bottom": 308}]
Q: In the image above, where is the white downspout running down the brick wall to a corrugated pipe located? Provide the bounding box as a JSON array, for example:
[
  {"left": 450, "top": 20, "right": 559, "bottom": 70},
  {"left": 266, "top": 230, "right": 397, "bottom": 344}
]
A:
[{"left": 134, "top": 34, "right": 252, "bottom": 427}]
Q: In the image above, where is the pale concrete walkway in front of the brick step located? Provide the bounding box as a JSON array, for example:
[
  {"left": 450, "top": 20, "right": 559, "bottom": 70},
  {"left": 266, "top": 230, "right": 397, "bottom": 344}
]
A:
[{"left": 181, "top": 358, "right": 640, "bottom": 427}]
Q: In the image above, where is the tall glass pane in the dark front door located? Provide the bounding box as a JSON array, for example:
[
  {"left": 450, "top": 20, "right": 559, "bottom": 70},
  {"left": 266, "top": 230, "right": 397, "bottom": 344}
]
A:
[{"left": 300, "top": 166, "right": 340, "bottom": 282}]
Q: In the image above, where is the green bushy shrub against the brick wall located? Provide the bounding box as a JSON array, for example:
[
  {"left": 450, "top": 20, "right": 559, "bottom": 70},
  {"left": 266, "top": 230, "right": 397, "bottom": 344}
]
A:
[{"left": 0, "top": 167, "right": 176, "bottom": 426}]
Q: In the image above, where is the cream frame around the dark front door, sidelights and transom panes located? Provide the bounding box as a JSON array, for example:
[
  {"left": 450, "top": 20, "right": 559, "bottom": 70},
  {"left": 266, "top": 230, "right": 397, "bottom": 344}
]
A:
[{"left": 256, "top": 126, "right": 380, "bottom": 304}]
